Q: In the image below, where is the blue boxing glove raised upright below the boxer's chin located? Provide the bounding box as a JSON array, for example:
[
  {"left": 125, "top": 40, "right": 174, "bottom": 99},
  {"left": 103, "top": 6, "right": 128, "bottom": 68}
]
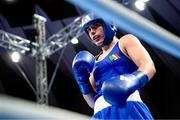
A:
[{"left": 72, "top": 51, "right": 95, "bottom": 94}]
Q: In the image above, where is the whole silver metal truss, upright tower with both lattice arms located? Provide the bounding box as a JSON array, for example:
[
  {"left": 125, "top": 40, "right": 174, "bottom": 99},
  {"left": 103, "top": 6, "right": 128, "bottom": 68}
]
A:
[{"left": 0, "top": 14, "right": 83, "bottom": 105}]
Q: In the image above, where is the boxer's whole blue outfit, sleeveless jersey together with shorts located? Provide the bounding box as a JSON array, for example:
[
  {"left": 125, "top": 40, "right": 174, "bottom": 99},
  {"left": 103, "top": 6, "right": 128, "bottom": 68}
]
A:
[{"left": 91, "top": 41, "right": 153, "bottom": 120}]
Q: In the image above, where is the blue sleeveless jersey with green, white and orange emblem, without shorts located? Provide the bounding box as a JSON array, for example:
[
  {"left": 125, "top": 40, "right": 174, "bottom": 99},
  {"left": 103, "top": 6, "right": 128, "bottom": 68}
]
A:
[{"left": 93, "top": 41, "right": 138, "bottom": 100}]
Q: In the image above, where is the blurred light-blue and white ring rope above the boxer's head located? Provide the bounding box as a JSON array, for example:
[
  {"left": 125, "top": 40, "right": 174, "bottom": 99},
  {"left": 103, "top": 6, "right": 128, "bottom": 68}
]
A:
[{"left": 68, "top": 0, "right": 180, "bottom": 58}]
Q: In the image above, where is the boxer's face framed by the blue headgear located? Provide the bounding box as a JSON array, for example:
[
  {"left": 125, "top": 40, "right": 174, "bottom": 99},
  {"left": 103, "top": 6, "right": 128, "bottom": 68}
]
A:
[{"left": 87, "top": 22, "right": 105, "bottom": 46}]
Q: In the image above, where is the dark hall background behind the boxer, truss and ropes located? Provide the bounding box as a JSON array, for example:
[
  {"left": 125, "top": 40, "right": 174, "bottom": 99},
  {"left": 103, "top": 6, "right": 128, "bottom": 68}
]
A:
[{"left": 0, "top": 0, "right": 180, "bottom": 119}]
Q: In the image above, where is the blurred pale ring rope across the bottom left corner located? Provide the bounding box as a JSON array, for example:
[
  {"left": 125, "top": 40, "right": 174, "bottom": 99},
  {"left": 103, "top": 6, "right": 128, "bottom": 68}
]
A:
[{"left": 0, "top": 95, "right": 90, "bottom": 120}]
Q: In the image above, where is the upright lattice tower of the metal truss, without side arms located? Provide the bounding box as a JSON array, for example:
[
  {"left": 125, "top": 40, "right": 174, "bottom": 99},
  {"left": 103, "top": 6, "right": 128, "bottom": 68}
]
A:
[{"left": 34, "top": 14, "right": 48, "bottom": 105}]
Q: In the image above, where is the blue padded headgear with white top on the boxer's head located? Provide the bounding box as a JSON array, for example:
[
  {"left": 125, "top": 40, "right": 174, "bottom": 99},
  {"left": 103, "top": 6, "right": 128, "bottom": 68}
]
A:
[{"left": 81, "top": 14, "right": 115, "bottom": 46}]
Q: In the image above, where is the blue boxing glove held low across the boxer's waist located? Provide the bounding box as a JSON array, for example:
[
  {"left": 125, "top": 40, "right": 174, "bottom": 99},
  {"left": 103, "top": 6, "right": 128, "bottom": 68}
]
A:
[{"left": 101, "top": 71, "right": 148, "bottom": 107}]
